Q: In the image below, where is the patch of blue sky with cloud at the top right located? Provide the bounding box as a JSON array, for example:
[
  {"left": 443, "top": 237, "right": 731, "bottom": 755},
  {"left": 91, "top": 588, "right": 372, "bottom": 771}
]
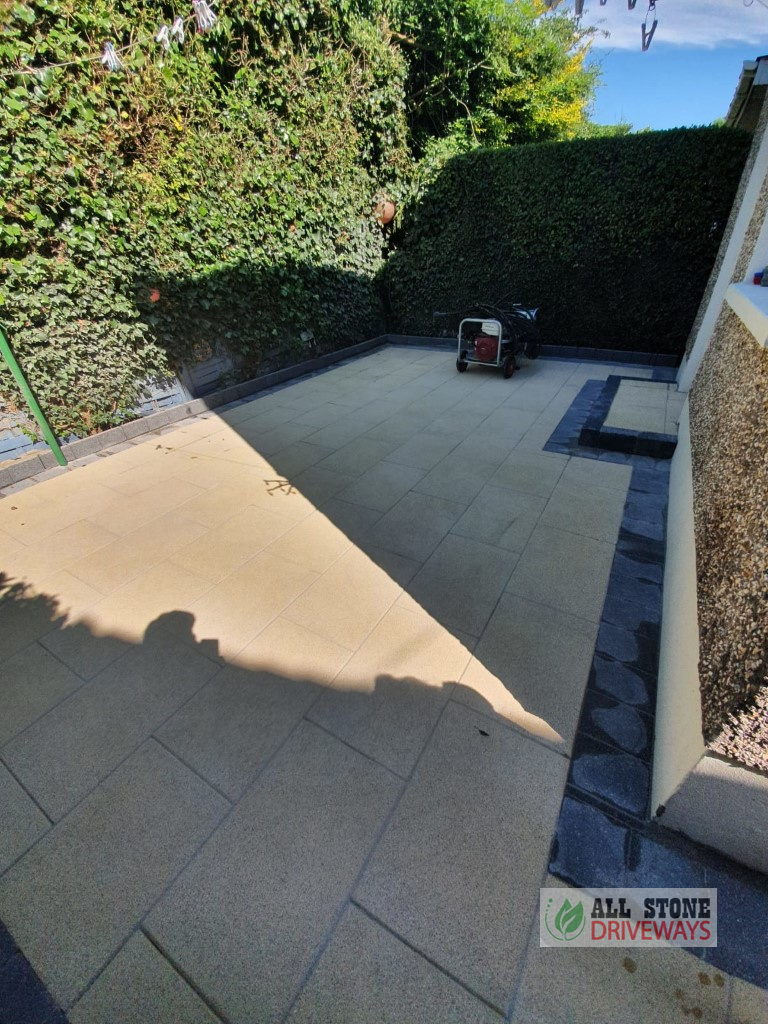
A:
[{"left": 584, "top": 0, "right": 768, "bottom": 129}]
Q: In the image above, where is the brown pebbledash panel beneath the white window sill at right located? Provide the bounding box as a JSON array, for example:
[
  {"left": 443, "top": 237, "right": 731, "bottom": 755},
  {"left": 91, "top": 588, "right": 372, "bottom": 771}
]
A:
[{"left": 689, "top": 306, "right": 768, "bottom": 771}]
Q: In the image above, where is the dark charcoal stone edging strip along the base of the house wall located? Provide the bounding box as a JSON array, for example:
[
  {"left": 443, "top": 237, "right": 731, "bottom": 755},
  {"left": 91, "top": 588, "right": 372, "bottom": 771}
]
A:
[{"left": 545, "top": 369, "right": 768, "bottom": 988}]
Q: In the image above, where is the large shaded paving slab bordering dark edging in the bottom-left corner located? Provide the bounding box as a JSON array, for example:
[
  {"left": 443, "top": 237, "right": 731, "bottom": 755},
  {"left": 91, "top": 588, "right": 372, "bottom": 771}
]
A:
[{"left": 0, "top": 741, "right": 229, "bottom": 1006}]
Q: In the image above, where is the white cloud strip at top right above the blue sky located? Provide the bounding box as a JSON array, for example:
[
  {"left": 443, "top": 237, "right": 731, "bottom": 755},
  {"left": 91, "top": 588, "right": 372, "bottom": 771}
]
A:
[{"left": 583, "top": 0, "right": 768, "bottom": 50}]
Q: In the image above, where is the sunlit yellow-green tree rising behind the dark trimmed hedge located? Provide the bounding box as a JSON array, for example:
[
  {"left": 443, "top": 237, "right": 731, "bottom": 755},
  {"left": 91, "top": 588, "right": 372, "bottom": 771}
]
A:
[{"left": 385, "top": 0, "right": 599, "bottom": 151}]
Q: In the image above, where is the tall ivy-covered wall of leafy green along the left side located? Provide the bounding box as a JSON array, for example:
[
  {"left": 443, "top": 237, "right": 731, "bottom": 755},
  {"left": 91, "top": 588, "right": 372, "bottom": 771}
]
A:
[{"left": 0, "top": 0, "right": 410, "bottom": 436}]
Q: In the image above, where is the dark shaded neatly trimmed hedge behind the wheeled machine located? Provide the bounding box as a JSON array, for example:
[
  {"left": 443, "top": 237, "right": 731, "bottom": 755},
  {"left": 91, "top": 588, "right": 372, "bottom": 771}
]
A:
[{"left": 386, "top": 128, "right": 751, "bottom": 354}]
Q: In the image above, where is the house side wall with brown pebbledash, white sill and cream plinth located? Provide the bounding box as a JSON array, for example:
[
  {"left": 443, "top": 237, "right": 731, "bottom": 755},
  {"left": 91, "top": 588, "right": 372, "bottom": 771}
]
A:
[{"left": 652, "top": 61, "right": 768, "bottom": 872}]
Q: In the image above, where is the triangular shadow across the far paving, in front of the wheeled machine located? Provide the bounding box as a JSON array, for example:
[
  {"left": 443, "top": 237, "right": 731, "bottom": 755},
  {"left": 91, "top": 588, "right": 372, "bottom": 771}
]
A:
[{"left": 191, "top": 352, "right": 606, "bottom": 753}]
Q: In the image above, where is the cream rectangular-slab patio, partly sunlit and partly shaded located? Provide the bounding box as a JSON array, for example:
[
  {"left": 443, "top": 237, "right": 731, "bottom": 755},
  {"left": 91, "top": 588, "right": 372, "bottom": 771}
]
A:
[{"left": 0, "top": 348, "right": 768, "bottom": 1024}]
